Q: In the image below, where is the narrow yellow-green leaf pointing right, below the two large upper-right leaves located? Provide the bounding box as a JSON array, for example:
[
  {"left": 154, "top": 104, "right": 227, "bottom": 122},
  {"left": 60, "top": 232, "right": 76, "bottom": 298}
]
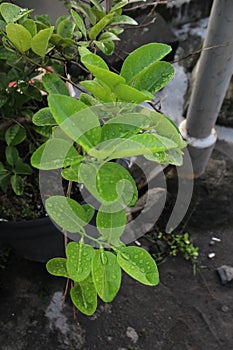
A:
[{"left": 114, "top": 84, "right": 154, "bottom": 103}]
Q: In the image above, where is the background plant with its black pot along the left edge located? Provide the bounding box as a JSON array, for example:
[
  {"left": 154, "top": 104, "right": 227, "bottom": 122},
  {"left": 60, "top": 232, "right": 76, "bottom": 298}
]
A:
[{"left": 0, "top": 2, "right": 142, "bottom": 261}]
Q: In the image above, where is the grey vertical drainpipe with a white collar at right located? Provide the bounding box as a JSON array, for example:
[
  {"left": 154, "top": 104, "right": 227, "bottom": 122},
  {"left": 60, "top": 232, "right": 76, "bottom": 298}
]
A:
[{"left": 180, "top": 0, "right": 233, "bottom": 177}]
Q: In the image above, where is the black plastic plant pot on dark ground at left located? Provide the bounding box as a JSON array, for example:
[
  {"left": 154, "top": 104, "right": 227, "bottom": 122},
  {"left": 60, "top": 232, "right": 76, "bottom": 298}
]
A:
[{"left": 0, "top": 218, "right": 64, "bottom": 262}]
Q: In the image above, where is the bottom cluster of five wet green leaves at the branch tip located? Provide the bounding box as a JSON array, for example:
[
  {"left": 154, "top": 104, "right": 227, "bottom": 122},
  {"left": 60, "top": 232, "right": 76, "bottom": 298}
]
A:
[{"left": 46, "top": 242, "right": 159, "bottom": 316}]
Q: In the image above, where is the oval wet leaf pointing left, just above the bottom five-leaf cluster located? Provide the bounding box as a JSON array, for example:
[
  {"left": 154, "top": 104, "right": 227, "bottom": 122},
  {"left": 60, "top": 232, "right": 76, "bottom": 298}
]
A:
[{"left": 45, "top": 196, "right": 87, "bottom": 233}]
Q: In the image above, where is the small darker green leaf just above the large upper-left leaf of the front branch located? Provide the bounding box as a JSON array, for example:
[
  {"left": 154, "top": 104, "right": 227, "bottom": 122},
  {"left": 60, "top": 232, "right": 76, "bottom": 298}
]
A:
[{"left": 42, "top": 73, "right": 70, "bottom": 96}]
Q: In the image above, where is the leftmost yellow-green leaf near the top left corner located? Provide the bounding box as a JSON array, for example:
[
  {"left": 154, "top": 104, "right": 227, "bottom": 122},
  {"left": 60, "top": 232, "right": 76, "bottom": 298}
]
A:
[{"left": 6, "top": 23, "right": 32, "bottom": 53}]
